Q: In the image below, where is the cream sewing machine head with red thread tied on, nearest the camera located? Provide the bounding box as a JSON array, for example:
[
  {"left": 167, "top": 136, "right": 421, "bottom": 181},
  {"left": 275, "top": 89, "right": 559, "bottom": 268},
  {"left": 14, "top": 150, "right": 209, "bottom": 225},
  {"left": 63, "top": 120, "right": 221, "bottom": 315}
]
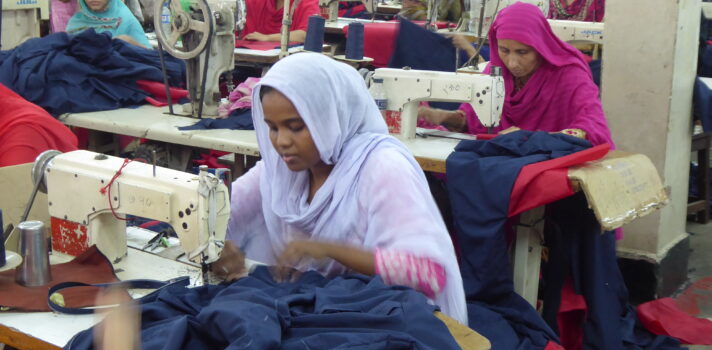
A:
[{"left": 32, "top": 150, "right": 230, "bottom": 274}]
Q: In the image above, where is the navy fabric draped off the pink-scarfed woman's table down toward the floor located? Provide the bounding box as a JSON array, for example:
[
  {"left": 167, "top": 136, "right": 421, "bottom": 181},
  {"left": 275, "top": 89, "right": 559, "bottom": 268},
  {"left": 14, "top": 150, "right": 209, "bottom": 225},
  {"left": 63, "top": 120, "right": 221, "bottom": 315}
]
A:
[{"left": 446, "top": 131, "right": 591, "bottom": 350}]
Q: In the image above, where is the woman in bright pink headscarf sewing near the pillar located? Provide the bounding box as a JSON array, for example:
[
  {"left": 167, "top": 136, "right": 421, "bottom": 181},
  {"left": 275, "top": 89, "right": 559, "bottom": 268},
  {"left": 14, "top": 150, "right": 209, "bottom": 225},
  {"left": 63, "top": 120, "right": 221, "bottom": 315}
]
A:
[{"left": 418, "top": 2, "right": 613, "bottom": 145}]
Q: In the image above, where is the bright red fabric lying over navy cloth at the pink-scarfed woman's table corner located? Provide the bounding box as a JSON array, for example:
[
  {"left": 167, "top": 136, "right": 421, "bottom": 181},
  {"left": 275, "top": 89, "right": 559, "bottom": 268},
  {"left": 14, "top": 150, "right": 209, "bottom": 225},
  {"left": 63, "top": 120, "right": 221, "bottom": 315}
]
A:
[{"left": 509, "top": 144, "right": 610, "bottom": 217}]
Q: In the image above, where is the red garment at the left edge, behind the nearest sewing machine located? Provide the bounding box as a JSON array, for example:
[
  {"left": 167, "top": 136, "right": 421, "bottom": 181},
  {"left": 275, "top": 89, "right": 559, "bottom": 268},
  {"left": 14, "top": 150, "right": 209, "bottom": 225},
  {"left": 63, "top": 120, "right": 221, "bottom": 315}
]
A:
[{"left": 0, "top": 84, "right": 77, "bottom": 167}]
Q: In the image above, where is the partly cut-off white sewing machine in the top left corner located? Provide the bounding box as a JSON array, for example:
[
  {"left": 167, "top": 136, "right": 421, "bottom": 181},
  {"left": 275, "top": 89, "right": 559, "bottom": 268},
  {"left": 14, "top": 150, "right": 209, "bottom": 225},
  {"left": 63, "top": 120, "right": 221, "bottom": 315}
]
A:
[{"left": 0, "top": 0, "right": 49, "bottom": 50}]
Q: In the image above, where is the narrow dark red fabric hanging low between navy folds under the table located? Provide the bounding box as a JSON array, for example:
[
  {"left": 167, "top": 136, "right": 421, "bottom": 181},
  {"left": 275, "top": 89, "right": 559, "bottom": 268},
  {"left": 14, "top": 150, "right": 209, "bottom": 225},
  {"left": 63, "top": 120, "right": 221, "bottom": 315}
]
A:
[{"left": 556, "top": 279, "right": 588, "bottom": 350}]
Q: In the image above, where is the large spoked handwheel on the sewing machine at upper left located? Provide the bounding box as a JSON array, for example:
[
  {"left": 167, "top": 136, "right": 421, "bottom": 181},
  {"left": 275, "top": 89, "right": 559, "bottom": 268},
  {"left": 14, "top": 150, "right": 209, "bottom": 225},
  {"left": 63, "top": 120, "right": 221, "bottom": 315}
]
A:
[{"left": 153, "top": 0, "right": 215, "bottom": 60}]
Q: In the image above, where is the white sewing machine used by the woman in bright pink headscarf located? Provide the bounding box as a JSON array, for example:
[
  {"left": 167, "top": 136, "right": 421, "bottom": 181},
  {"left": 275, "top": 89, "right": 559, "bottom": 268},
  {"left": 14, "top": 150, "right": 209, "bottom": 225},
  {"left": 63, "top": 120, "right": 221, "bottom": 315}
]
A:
[{"left": 369, "top": 67, "right": 505, "bottom": 139}]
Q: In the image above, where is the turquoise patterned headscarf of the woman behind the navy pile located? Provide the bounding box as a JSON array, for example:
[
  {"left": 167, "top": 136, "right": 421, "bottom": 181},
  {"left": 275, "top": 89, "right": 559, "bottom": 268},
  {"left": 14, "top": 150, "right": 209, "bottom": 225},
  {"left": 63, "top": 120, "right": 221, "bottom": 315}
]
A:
[{"left": 67, "top": 0, "right": 151, "bottom": 49}]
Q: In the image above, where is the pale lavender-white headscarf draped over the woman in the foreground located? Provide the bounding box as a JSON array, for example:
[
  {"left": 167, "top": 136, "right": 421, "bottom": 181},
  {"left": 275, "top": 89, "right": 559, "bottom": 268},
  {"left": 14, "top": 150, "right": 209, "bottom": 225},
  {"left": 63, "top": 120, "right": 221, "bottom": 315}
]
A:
[{"left": 242, "top": 53, "right": 467, "bottom": 324}]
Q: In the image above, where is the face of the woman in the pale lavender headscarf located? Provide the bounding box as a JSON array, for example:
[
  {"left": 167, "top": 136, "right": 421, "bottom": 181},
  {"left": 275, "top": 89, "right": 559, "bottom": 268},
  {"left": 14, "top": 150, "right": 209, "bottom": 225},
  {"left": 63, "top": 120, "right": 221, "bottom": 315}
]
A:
[{"left": 262, "top": 90, "right": 322, "bottom": 171}]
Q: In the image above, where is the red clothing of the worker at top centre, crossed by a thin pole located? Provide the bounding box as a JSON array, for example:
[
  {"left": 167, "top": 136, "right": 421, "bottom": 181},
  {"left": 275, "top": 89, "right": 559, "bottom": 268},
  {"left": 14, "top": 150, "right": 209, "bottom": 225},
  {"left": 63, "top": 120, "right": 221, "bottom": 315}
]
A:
[{"left": 242, "top": 0, "right": 321, "bottom": 36}]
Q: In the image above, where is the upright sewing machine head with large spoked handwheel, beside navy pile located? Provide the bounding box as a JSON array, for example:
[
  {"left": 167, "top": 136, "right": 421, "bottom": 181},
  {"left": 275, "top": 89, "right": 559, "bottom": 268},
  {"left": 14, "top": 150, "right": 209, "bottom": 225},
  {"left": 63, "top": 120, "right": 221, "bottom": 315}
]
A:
[{"left": 154, "top": 0, "right": 239, "bottom": 118}]
